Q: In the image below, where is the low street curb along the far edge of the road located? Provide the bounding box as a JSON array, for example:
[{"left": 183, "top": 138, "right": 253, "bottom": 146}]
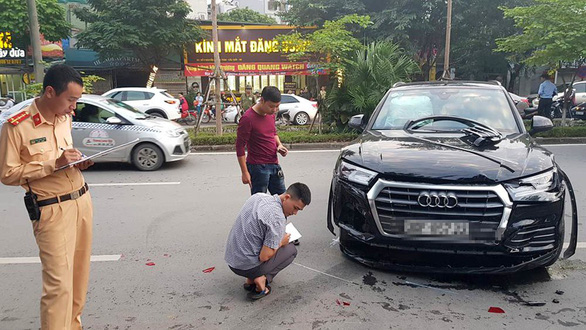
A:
[{"left": 191, "top": 137, "right": 586, "bottom": 152}]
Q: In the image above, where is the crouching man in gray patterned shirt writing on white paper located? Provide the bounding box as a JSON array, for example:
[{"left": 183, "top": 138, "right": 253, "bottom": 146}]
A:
[{"left": 224, "top": 182, "right": 311, "bottom": 300}]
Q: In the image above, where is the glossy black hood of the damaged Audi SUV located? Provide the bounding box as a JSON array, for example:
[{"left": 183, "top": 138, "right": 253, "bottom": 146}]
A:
[{"left": 341, "top": 131, "right": 554, "bottom": 184}]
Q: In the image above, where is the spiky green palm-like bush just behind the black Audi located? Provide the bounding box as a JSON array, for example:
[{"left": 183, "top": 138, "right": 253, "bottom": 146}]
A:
[{"left": 324, "top": 41, "right": 419, "bottom": 127}]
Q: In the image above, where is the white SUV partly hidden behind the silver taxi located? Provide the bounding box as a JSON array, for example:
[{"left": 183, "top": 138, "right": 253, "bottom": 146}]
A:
[{"left": 102, "top": 87, "right": 181, "bottom": 120}]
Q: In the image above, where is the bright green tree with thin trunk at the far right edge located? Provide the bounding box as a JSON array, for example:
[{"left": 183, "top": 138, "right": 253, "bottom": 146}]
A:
[{"left": 497, "top": 0, "right": 586, "bottom": 125}]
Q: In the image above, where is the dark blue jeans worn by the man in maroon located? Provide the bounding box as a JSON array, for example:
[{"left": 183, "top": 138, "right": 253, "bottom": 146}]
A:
[{"left": 246, "top": 164, "right": 287, "bottom": 195}]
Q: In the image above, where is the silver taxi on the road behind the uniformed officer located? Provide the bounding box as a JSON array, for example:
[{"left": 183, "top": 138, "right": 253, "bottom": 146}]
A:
[{"left": 0, "top": 95, "right": 191, "bottom": 171}]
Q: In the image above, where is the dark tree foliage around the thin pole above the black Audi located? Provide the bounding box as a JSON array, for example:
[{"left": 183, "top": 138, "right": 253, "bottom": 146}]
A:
[{"left": 282, "top": 0, "right": 533, "bottom": 80}]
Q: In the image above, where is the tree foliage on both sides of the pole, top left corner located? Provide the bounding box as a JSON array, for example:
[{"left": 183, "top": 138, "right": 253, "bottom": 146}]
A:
[{"left": 0, "top": 0, "right": 71, "bottom": 48}]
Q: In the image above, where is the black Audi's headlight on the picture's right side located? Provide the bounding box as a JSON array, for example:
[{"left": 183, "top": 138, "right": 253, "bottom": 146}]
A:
[{"left": 504, "top": 168, "right": 560, "bottom": 202}]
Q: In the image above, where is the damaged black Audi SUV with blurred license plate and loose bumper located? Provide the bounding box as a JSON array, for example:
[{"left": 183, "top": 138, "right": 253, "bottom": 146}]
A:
[{"left": 327, "top": 81, "right": 577, "bottom": 273}]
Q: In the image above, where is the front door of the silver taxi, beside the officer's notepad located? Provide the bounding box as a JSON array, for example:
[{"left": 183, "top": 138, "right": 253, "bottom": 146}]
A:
[{"left": 71, "top": 101, "right": 129, "bottom": 161}]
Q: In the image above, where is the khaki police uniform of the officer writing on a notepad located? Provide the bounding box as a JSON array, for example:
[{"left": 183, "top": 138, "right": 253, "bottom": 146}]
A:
[{"left": 0, "top": 101, "right": 93, "bottom": 330}]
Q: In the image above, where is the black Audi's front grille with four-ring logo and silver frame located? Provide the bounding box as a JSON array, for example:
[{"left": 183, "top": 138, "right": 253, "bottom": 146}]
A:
[{"left": 369, "top": 180, "right": 508, "bottom": 241}]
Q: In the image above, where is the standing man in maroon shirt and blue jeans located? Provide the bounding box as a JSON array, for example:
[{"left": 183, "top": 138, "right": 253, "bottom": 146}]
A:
[{"left": 236, "top": 86, "right": 288, "bottom": 195}]
